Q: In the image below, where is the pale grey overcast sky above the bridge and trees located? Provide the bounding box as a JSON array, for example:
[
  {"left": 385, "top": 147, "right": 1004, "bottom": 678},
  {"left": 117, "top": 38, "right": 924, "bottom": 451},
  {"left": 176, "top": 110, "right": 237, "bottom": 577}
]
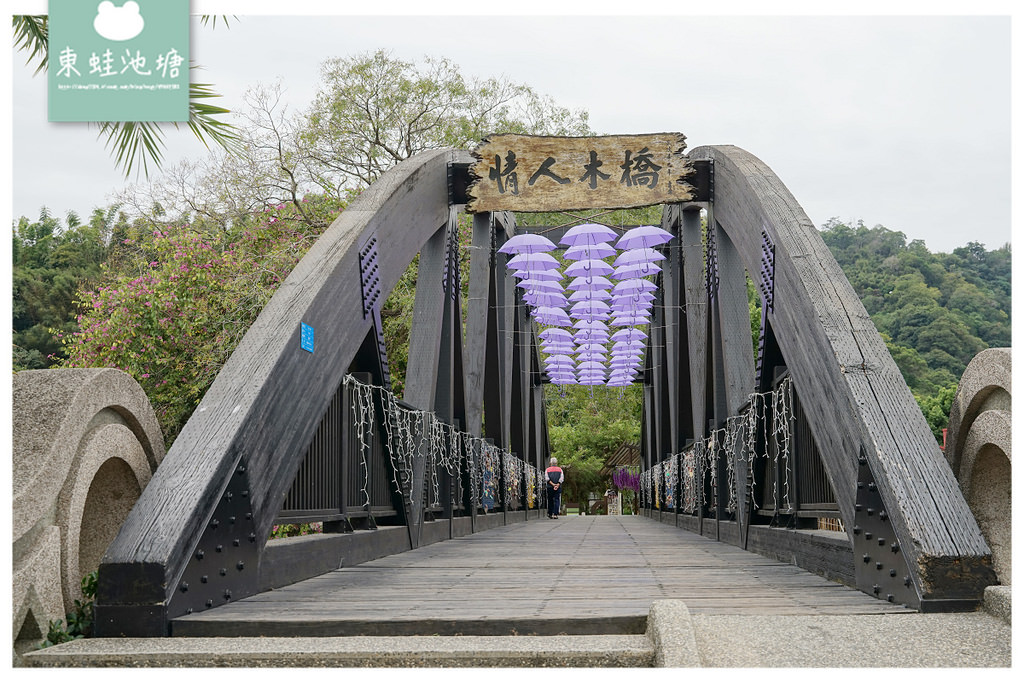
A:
[{"left": 11, "top": 8, "right": 1011, "bottom": 251}]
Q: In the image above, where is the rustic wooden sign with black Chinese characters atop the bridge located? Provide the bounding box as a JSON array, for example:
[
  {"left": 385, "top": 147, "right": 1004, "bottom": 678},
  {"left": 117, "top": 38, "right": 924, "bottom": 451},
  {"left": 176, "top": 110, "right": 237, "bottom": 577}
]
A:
[{"left": 466, "top": 133, "right": 693, "bottom": 213}]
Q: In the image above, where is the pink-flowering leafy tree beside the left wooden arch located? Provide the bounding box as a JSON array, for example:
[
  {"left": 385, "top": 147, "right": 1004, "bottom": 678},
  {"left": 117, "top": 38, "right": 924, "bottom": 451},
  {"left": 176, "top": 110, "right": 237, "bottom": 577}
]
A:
[{"left": 62, "top": 194, "right": 352, "bottom": 445}]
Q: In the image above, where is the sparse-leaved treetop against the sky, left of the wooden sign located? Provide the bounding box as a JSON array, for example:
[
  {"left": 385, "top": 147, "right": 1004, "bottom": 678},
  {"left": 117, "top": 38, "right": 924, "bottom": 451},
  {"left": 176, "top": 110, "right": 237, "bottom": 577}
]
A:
[{"left": 302, "top": 50, "right": 590, "bottom": 185}]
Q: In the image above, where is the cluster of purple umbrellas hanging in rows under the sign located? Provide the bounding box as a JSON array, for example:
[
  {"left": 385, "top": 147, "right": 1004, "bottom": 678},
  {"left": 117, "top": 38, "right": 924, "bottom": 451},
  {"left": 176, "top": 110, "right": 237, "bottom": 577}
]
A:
[{"left": 499, "top": 223, "right": 672, "bottom": 387}]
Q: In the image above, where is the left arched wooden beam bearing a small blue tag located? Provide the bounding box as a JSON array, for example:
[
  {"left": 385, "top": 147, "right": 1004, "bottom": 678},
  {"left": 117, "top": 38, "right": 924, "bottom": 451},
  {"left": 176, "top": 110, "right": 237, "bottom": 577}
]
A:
[{"left": 96, "top": 150, "right": 470, "bottom": 636}]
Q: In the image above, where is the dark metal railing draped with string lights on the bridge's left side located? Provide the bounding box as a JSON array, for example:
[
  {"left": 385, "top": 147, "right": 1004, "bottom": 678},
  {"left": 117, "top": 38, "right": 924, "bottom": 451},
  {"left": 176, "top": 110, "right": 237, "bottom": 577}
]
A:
[{"left": 275, "top": 375, "right": 545, "bottom": 531}]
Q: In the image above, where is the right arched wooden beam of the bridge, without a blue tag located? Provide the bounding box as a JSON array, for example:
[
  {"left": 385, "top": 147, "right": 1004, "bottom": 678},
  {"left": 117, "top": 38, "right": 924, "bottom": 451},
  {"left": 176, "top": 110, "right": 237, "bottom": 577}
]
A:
[{"left": 687, "top": 145, "right": 995, "bottom": 609}]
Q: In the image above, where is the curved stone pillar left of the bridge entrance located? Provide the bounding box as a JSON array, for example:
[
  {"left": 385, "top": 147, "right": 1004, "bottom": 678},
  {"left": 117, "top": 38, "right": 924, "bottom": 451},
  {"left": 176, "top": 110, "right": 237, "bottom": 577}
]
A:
[{"left": 12, "top": 369, "right": 164, "bottom": 664}]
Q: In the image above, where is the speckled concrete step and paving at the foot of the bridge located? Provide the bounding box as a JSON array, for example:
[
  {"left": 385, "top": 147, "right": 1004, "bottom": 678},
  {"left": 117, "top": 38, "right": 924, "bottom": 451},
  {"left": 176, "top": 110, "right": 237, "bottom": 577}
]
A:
[{"left": 22, "top": 600, "right": 1012, "bottom": 668}]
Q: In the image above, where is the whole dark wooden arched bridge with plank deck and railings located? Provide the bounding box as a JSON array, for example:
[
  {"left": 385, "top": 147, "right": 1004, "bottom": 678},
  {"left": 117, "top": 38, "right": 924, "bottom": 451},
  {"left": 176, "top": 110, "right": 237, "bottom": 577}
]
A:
[{"left": 95, "top": 140, "right": 995, "bottom": 636}]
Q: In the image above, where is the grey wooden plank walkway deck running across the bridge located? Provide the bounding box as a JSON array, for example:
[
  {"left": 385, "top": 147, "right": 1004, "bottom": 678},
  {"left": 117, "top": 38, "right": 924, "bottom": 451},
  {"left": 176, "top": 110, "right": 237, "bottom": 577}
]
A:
[{"left": 172, "top": 516, "right": 909, "bottom": 636}]
